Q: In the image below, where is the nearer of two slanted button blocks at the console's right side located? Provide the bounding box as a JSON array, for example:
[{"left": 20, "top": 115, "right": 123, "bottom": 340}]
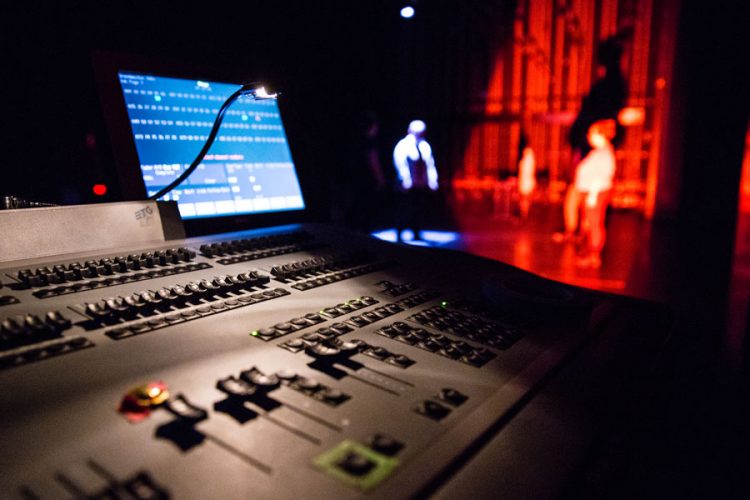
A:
[{"left": 376, "top": 321, "right": 495, "bottom": 367}]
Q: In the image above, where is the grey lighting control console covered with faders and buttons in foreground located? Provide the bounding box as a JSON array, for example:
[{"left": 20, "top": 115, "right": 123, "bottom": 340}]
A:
[{"left": 0, "top": 225, "right": 658, "bottom": 499}]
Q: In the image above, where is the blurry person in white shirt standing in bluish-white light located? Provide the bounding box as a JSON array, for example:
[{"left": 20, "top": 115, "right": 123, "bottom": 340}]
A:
[{"left": 393, "top": 120, "right": 438, "bottom": 239}]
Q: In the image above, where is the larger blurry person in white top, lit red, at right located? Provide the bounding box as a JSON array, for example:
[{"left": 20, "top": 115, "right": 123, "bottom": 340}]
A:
[{"left": 574, "top": 119, "right": 616, "bottom": 268}]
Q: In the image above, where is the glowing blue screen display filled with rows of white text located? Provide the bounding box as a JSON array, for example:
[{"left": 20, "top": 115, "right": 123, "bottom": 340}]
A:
[{"left": 118, "top": 71, "right": 305, "bottom": 219}]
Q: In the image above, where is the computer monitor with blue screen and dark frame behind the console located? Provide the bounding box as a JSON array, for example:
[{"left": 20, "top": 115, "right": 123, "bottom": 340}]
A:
[{"left": 94, "top": 54, "right": 306, "bottom": 229}]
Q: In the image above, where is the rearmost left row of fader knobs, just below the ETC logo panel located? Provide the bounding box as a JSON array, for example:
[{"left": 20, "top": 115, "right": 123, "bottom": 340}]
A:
[{"left": 16, "top": 247, "right": 195, "bottom": 287}]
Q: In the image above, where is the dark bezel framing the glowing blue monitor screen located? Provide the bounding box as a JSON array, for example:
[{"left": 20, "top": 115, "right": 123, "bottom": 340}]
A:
[{"left": 91, "top": 51, "right": 311, "bottom": 236}]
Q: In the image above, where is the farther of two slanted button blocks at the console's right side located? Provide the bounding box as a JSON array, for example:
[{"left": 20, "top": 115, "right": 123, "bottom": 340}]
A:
[{"left": 408, "top": 306, "right": 522, "bottom": 350}]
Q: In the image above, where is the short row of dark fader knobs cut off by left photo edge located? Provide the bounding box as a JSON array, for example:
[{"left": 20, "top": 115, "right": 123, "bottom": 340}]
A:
[{"left": 0, "top": 311, "right": 71, "bottom": 351}]
